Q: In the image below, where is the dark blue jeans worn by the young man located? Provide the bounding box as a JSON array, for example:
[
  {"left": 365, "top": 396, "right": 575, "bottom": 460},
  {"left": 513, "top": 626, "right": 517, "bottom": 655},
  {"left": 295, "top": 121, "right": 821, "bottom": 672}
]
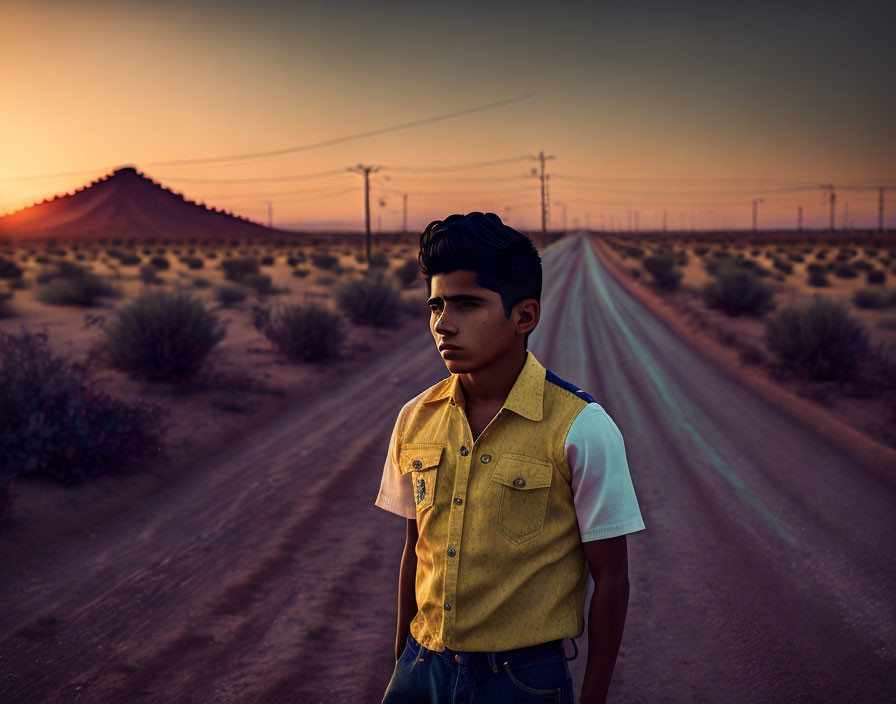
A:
[{"left": 382, "top": 634, "right": 573, "bottom": 704}]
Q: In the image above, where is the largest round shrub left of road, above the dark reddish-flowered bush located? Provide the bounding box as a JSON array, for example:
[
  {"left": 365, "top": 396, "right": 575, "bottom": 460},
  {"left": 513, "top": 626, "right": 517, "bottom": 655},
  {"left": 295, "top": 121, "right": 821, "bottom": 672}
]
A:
[{"left": 95, "top": 289, "right": 226, "bottom": 381}]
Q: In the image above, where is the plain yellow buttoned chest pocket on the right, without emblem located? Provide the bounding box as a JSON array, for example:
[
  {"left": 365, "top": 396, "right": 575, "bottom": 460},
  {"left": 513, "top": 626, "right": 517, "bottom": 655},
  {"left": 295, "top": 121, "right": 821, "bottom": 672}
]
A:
[{"left": 492, "top": 454, "right": 553, "bottom": 545}]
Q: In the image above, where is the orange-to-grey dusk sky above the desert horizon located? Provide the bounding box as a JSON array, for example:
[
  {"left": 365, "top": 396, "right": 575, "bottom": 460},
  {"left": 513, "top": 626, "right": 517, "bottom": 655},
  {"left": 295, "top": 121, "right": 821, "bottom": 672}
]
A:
[{"left": 0, "top": 0, "right": 896, "bottom": 231}]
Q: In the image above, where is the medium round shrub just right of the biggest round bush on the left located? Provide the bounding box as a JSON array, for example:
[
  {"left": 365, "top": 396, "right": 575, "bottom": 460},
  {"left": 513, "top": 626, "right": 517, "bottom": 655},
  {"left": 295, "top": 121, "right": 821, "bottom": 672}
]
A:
[{"left": 262, "top": 302, "right": 345, "bottom": 362}]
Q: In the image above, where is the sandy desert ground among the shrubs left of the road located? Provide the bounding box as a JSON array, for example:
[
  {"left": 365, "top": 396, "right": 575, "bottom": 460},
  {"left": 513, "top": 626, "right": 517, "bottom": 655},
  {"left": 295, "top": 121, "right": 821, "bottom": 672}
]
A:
[{"left": 0, "top": 246, "right": 428, "bottom": 552}]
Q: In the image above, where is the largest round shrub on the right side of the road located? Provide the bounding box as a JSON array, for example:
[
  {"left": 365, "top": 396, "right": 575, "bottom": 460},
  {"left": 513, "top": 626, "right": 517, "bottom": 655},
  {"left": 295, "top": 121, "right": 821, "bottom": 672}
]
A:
[{"left": 765, "top": 294, "right": 870, "bottom": 381}]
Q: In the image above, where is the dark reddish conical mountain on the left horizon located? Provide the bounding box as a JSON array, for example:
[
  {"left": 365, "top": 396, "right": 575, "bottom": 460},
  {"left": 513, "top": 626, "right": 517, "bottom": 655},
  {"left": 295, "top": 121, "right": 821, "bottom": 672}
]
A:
[{"left": 0, "top": 166, "right": 295, "bottom": 241}]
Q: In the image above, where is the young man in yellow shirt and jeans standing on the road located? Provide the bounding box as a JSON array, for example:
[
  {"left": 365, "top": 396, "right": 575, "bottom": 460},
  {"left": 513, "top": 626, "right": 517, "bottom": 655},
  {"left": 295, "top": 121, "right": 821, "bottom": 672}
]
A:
[{"left": 376, "top": 212, "right": 645, "bottom": 704}]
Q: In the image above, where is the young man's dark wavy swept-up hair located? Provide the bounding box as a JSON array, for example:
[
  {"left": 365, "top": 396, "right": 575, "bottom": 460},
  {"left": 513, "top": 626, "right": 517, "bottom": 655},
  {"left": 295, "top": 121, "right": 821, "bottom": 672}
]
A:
[{"left": 417, "top": 212, "right": 541, "bottom": 345}]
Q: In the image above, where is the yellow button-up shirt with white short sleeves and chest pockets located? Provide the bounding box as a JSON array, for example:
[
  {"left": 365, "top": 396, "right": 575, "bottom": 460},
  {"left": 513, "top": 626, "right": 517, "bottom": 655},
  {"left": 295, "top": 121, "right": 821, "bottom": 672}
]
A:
[{"left": 376, "top": 350, "right": 644, "bottom": 651}]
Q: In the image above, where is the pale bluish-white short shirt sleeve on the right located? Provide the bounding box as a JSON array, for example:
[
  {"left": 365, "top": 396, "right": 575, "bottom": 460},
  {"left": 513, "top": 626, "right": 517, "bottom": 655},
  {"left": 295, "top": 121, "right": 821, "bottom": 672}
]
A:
[{"left": 565, "top": 403, "right": 645, "bottom": 543}]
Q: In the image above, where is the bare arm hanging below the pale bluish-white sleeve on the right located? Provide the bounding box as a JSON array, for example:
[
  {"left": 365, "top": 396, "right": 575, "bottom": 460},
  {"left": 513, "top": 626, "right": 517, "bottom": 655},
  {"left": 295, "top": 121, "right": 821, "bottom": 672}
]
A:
[{"left": 579, "top": 535, "right": 629, "bottom": 704}]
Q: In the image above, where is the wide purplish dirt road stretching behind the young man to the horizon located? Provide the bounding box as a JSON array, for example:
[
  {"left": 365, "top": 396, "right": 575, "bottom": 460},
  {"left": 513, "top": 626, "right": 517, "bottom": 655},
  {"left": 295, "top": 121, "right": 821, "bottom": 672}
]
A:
[{"left": 0, "top": 237, "right": 896, "bottom": 704}]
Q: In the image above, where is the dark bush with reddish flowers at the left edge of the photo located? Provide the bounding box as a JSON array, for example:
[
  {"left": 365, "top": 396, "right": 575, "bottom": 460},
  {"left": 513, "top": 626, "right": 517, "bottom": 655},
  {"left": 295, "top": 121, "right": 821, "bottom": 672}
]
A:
[{"left": 0, "top": 328, "right": 166, "bottom": 484}]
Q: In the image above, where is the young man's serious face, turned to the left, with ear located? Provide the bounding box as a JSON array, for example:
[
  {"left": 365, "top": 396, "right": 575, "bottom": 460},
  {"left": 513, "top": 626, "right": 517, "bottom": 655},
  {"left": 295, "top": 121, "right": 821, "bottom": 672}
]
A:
[{"left": 427, "top": 269, "right": 538, "bottom": 374}]
